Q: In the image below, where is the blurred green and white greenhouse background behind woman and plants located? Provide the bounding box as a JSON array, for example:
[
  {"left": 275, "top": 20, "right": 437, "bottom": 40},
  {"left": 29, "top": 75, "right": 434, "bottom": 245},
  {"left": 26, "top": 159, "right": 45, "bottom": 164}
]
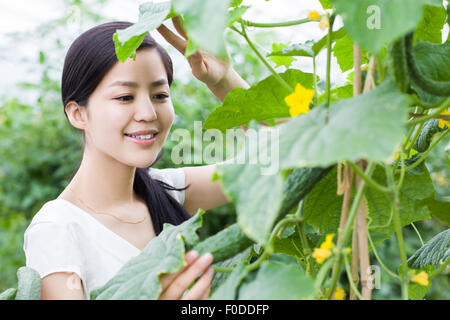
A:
[{"left": 0, "top": 0, "right": 450, "bottom": 299}]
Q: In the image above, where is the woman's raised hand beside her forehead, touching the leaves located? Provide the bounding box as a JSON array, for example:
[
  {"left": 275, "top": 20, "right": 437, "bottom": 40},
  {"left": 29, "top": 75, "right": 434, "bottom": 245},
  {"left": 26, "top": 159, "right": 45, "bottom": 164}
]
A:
[{"left": 157, "top": 16, "right": 232, "bottom": 87}]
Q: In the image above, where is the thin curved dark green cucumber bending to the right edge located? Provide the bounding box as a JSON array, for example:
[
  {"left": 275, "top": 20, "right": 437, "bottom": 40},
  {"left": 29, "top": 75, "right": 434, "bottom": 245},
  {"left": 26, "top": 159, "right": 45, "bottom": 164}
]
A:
[{"left": 404, "top": 32, "right": 450, "bottom": 97}]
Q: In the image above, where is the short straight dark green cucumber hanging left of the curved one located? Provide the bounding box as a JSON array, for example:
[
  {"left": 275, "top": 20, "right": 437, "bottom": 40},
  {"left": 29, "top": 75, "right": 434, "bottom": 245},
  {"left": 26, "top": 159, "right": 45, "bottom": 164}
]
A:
[{"left": 386, "top": 37, "right": 410, "bottom": 93}]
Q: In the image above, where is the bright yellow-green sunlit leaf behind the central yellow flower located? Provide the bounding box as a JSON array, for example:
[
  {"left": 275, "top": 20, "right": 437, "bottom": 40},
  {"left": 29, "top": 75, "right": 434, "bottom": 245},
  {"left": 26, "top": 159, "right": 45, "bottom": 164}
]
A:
[{"left": 203, "top": 69, "right": 313, "bottom": 132}]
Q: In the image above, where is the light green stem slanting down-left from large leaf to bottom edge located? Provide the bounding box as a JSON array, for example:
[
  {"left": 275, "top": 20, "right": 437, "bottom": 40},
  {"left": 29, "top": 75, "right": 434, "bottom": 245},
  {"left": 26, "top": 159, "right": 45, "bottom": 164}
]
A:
[{"left": 327, "top": 162, "right": 375, "bottom": 299}]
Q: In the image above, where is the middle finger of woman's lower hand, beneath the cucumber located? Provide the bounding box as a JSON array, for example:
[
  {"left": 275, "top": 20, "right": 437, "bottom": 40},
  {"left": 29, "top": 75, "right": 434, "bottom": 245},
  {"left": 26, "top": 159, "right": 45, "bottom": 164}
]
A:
[{"left": 160, "top": 253, "right": 213, "bottom": 299}]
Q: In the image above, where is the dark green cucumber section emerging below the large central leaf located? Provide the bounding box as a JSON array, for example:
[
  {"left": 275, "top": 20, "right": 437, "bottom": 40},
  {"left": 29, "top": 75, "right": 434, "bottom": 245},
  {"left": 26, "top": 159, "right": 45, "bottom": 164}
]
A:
[{"left": 277, "top": 166, "right": 333, "bottom": 221}]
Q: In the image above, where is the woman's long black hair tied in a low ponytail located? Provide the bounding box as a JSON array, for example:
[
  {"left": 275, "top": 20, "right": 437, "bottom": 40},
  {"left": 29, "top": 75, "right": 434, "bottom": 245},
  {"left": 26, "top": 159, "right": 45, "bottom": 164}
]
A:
[{"left": 61, "top": 21, "right": 190, "bottom": 235}]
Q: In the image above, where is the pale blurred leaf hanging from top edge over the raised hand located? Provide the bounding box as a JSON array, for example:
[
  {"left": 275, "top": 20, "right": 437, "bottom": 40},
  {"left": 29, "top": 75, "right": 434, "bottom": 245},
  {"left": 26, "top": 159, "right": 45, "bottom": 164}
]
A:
[{"left": 172, "top": 0, "right": 229, "bottom": 59}]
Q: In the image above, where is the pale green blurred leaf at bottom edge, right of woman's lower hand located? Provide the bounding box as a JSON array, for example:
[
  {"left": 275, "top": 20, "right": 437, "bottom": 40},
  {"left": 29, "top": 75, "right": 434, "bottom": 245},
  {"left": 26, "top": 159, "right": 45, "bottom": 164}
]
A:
[{"left": 239, "top": 256, "right": 314, "bottom": 300}]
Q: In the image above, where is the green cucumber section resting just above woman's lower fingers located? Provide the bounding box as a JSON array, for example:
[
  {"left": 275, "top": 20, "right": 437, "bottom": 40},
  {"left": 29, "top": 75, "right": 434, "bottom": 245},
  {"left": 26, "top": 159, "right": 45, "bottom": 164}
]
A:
[{"left": 188, "top": 222, "right": 253, "bottom": 262}]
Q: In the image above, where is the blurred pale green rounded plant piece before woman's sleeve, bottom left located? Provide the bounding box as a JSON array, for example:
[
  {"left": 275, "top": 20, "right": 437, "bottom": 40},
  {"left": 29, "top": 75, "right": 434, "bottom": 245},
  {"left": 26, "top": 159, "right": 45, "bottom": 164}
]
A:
[{"left": 16, "top": 267, "right": 41, "bottom": 300}]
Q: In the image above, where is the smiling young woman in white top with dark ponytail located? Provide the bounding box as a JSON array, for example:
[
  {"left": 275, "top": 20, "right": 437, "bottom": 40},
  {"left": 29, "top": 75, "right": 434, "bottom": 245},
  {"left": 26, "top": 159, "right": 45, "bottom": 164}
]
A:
[{"left": 24, "top": 18, "right": 248, "bottom": 299}]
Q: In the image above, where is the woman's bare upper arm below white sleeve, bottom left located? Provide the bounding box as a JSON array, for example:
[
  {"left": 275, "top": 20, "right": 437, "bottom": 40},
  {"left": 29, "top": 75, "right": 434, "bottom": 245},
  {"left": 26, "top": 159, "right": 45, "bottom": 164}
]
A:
[{"left": 41, "top": 272, "right": 86, "bottom": 300}]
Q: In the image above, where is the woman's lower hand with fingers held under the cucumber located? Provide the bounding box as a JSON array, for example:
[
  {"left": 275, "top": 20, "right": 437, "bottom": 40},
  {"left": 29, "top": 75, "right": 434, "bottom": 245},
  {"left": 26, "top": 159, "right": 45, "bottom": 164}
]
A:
[{"left": 158, "top": 251, "right": 214, "bottom": 300}]
